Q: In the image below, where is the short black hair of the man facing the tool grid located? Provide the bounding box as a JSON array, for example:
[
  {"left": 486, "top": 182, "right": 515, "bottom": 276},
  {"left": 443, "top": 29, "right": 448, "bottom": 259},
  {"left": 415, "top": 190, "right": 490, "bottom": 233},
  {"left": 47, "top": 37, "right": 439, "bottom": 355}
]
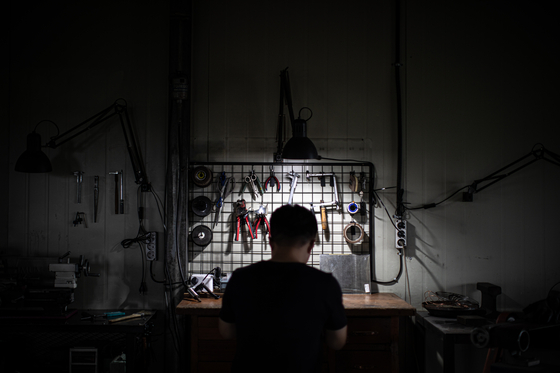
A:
[{"left": 270, "top": 205, "right": 317, "bottom": 246}]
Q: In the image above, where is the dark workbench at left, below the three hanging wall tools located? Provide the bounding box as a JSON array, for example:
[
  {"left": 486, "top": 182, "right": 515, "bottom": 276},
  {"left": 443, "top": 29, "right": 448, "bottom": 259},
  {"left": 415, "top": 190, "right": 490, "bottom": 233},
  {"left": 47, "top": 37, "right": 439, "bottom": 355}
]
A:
[{"left": 0, "top": 310, "right": 156, "bottom": 373}]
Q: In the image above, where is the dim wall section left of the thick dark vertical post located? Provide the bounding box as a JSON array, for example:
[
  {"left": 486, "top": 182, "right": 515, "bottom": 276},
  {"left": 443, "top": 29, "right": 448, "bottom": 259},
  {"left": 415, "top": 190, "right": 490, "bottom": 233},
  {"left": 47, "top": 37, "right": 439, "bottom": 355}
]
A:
[{"left": 4, "top": 0, "right": 169, "bottom": 308}]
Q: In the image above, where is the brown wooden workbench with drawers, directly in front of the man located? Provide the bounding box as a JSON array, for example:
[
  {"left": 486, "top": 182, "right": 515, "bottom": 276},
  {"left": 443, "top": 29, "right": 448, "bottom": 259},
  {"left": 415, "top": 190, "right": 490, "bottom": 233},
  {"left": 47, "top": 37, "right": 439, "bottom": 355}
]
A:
[{"left": 176, "top": 293, "right": 416, "bottom": 373}]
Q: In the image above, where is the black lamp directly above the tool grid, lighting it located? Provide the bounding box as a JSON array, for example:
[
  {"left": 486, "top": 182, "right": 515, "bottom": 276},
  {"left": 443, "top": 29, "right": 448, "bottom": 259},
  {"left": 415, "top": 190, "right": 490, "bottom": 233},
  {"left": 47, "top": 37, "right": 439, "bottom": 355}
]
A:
[{"left": 274, "top": 68, "right": 321, "bottom": 162}]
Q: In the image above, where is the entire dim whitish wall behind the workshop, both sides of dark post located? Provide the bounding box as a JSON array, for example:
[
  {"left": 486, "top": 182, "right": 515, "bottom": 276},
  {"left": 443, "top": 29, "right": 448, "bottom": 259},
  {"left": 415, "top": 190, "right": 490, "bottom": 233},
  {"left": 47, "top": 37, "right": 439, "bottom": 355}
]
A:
[{"left": 5, "top": 0, "right": 560, "bottom": 309}]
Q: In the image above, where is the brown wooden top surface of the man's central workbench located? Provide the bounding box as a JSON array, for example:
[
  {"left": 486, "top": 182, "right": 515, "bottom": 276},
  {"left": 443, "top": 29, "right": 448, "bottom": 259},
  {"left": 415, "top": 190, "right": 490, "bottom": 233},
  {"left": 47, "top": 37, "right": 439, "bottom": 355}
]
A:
[{"left": 176, "top": 293, "right": 416, "bottom": 316}]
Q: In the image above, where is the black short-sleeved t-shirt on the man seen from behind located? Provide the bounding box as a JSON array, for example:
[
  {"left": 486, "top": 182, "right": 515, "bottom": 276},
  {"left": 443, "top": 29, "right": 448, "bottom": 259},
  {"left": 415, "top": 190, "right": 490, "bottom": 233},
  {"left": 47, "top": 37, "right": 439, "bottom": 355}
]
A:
[{"left": 220, "top": 261, "right": 346, "bottom": 373}]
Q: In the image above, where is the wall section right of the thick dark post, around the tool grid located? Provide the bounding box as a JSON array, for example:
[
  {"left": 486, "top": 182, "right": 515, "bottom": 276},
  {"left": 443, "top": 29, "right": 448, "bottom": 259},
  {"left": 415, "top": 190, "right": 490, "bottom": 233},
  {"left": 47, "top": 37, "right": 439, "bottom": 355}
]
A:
[{"left": 191, "top": 0, "right": 560, "bottom": 309}]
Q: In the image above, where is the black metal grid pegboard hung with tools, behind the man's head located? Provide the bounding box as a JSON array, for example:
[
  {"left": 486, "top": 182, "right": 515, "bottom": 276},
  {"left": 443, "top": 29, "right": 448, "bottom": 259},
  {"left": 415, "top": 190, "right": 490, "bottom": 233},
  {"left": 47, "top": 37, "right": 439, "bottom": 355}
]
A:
[{"left": 187, "top": 162, "right": 373, "bottom": 274}]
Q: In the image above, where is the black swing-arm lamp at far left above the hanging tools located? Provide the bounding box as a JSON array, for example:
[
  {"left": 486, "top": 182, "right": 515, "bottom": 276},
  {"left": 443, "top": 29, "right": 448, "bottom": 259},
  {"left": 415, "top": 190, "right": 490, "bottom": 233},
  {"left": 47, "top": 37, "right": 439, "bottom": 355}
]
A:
[{"left": 15, "top": 99, "right": 150, "bottom": 191}]
